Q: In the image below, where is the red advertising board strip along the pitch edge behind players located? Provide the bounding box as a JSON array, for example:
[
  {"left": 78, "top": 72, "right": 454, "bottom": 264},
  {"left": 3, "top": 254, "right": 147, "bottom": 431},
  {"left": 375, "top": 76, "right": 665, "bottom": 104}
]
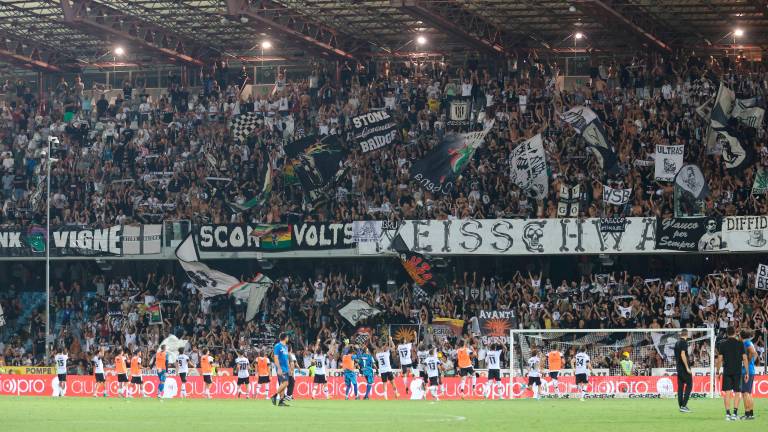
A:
[{"left": 0, "top": 375, "right": 768, "bottom": 399}]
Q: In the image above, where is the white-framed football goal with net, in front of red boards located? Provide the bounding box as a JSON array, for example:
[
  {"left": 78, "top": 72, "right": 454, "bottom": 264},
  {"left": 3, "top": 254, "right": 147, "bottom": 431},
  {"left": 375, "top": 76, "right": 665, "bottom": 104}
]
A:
[{"left": 509, "top": 328, "right": 716, "bottom": 398}]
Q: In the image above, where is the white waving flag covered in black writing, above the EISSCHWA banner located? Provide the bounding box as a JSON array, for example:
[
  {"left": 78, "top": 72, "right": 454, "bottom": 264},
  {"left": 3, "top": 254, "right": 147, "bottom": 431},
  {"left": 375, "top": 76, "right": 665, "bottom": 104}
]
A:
[{"left": 509, "top": 134, "right": 549, "bottom": 199}]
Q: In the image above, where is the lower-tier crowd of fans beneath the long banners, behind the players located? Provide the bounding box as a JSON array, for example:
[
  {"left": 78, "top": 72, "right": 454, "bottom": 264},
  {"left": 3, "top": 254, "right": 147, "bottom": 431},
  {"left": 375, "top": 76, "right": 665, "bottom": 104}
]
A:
[{"left": 0, "top": 258, "right": 768, "bottom": 373}]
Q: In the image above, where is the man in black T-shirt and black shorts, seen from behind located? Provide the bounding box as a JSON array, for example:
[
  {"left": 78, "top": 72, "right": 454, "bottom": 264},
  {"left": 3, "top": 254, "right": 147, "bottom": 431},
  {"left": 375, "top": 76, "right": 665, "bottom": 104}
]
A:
[{"left": 715, "top": 327, "right": 749, "bottom": 421}]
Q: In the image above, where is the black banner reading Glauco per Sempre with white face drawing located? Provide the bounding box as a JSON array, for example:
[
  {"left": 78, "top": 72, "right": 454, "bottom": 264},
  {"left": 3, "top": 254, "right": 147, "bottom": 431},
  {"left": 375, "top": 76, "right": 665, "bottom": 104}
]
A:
[{"left": 656, "top": 217, "right": 727, "bottom": 251}]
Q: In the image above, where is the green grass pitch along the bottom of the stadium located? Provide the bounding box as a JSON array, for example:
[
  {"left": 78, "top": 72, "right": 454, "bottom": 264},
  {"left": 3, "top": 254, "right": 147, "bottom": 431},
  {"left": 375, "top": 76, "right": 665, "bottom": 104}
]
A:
[{"left": 0, "top": 396, "right": 768, "bottom": 432}]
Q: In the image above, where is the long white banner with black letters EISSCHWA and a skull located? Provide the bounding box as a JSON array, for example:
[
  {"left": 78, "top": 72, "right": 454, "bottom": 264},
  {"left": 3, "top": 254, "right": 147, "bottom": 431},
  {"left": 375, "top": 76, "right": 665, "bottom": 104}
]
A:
[{"left": 358, "top": 217, "right": 656, "bottom": 255}]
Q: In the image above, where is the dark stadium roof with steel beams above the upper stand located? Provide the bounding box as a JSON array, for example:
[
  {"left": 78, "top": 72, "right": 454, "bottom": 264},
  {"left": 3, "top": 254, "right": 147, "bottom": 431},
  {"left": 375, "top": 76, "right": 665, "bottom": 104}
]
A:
[{"left": 0, "top": 0, "right": 768, "bottom": 72}]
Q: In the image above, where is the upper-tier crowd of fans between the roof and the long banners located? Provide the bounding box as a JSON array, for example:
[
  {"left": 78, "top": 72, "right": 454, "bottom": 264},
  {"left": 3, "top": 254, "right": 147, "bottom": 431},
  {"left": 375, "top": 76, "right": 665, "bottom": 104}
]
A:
[{"left": 0, "top": 52, "right": 768, "bottom": 225}]
